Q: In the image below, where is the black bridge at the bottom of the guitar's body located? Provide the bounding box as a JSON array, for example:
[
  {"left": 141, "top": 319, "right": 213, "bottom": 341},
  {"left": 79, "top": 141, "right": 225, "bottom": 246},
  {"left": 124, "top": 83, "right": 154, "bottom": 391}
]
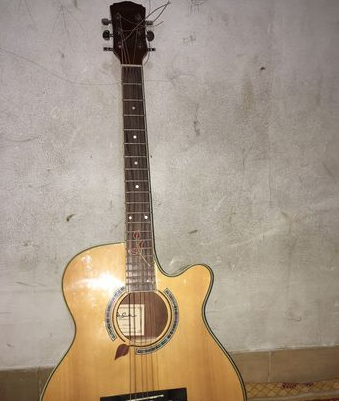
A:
[{"left": 100, "top": 388, "right": 188, "bottom": 401}]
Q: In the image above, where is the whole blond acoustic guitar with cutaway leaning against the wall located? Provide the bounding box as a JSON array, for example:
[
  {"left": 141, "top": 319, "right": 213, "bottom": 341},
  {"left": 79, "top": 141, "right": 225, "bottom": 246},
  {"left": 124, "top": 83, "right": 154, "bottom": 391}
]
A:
[{"left": 42, "top": 1, "right": 246, "bottom": 401}]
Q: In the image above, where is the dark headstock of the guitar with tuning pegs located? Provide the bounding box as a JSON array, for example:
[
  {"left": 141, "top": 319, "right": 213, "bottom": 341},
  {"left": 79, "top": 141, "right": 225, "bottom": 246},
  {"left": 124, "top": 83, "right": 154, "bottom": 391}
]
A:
[{"left": 102, "top": 1, "right": 149, "bottom": 65}]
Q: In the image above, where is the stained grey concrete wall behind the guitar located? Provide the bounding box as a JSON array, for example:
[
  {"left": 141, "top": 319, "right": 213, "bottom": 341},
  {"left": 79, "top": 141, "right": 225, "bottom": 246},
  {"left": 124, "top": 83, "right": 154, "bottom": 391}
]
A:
[{"left": 0, "top": 0, "right": 339, "bottom": 369}]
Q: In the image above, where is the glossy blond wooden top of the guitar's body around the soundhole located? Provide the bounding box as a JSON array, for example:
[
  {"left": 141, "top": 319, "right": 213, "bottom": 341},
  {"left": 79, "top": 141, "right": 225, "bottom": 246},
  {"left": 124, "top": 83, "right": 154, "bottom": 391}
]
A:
[{"left": 43, "top": 244, "right": 245, "bottom": 401}]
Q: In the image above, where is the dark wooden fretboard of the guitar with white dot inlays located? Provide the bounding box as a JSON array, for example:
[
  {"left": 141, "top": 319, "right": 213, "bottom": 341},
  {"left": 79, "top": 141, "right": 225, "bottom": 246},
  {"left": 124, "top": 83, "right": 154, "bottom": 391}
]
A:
[{"left": 121, "top": 65, "right": 156, "bottom": 292}]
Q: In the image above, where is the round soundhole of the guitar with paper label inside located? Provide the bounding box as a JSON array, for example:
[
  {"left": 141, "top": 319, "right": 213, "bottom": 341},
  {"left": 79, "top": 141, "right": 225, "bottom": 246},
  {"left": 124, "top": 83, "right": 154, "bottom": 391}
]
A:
[{"left": 114, "top": 291, "right": 170, "bottom": 346}]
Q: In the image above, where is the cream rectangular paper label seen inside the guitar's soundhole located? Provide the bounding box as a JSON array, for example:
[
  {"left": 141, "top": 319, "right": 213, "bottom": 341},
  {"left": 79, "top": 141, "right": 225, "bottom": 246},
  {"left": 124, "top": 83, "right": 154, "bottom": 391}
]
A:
[{"left": 117, "top": 304, "right": 145, "bottom": 337}]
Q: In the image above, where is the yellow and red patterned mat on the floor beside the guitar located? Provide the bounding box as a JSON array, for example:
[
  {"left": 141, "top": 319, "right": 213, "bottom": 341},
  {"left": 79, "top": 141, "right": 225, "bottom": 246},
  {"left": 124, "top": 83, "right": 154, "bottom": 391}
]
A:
[{"left": 246, "top": 379, "right": 339, "bottom": 401}]
